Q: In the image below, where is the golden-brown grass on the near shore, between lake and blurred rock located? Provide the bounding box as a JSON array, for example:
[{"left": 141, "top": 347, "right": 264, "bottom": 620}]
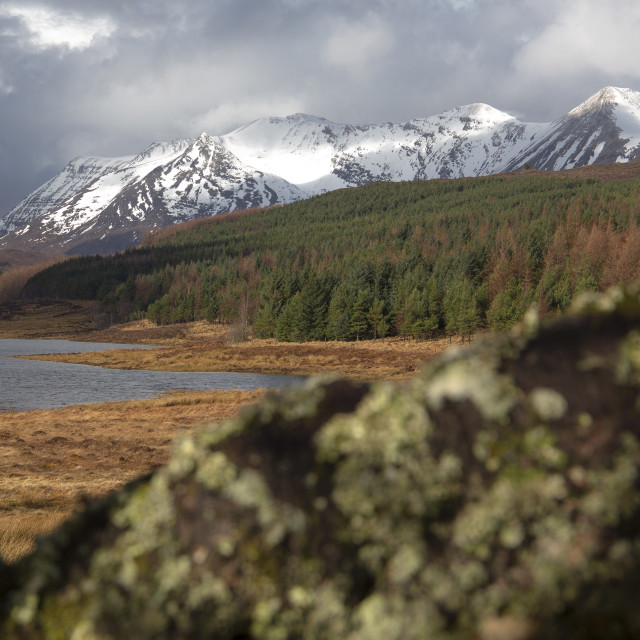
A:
[{"left": 0, "top": 390, "right": 264, "bottom": 562}]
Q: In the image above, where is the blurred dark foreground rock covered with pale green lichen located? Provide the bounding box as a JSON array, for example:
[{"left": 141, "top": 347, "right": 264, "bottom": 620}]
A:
[{"left": 0, "top": 289, "right": 640, "bottom": 640}]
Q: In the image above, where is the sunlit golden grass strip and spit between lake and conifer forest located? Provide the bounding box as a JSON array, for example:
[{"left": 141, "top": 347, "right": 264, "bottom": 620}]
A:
[{"left": 21, "top": 321, "right": 470, "bottom": 380}]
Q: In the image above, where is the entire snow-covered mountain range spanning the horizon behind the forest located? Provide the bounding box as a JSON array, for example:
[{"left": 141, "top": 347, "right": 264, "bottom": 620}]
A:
[{"left": 0, "top": 87, "right": 640, "bottom": 253}]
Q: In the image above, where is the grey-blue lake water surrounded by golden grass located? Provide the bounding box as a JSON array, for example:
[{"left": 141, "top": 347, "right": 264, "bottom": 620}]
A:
[{"left": 0, "top": 340, "right": 304, "bottom": 411}]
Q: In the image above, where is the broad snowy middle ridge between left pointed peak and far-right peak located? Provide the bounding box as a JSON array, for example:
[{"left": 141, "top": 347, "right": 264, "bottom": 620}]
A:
[{"left": 222, "top": 104, "right": 544, "bottom": 194}]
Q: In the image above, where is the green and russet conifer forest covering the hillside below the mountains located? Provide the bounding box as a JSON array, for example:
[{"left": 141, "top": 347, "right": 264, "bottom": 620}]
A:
[{"left": 25, "top": 174, "right": 640, "bottom": 341}]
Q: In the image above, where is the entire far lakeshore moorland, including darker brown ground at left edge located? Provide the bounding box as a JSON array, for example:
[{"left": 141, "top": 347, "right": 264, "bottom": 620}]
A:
[{"left": 0, "top": 301, "right": 470, "bottom": 382}]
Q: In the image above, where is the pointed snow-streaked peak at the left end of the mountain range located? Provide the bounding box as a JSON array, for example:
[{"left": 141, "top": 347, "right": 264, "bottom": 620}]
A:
[{"left": 0, "top": 133, "right": 307, "bottom": 253}]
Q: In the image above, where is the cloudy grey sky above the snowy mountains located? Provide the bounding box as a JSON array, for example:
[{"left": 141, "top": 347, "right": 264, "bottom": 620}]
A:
[{"left": 0, "top": 0, "right": 640, "bottom": 215}]
